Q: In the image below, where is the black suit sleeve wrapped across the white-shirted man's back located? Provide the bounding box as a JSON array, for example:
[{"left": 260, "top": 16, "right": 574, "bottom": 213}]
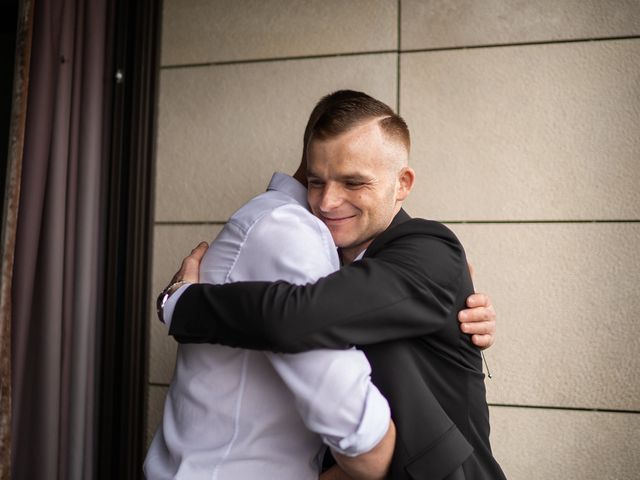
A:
[{"left": 170, "top": 220, "right": 470, "bottom": 353}]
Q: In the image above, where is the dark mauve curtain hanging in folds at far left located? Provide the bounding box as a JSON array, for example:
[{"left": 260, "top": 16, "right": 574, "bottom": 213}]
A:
[{"left": 11, "top": 0, "right": 112, "bottom": 479}]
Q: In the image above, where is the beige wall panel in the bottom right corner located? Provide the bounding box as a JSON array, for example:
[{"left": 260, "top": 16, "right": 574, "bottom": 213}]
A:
[{"left": 491, "top": 407, "right": 640, "bottom": 480}]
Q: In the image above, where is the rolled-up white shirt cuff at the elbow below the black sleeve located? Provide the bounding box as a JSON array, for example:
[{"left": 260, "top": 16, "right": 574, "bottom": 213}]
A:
[{"left": 331, "top": 383, "right": 391, "bottom": 457}]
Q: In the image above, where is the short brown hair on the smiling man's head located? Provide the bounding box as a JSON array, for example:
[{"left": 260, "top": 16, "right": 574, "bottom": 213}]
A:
[{"left": 304, "top": 90, "right": 411, "bottom": 151}]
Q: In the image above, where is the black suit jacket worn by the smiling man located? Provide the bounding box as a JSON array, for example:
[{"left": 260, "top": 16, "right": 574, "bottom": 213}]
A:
[{"left": 170, "top": 210, "right": 504, "bottom": 480}]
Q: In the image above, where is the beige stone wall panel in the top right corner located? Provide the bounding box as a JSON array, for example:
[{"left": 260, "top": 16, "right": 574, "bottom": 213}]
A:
[{"left": 401, "top": 0, "right": 640, "bottom": 50}]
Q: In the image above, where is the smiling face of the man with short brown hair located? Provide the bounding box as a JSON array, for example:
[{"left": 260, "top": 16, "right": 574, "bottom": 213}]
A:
[{"left": 307, "top": 118, "right": 414, "bottom": 263}]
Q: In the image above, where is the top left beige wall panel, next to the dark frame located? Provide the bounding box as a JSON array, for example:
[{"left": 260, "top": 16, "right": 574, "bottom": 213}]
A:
[{"left": 162, "top": 0, "right": 398, "bottom": 65}]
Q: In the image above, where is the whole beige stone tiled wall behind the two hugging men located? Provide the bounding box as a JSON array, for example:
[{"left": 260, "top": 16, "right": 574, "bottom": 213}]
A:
[{"left": 148, "top": 0, "right": 640, "bottom": 480}]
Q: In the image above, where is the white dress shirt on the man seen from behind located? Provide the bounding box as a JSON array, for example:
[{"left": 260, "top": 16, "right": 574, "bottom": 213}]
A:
[{"left": 144, "top": 173, "right": 390, "bottom": 480}]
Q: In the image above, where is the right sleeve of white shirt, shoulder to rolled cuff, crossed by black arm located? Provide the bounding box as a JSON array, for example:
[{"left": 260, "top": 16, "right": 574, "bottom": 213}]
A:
[{"left": 230, "top": 205, "right": 390, "bottom": 456}]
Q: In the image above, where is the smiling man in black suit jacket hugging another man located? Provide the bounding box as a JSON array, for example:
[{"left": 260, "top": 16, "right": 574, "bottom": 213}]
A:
[{"left": 161, "top": 92, "right": 504, "bottom": 479}]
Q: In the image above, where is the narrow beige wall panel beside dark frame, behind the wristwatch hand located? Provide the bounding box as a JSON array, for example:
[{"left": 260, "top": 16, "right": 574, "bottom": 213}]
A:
[{"left": 149, "top": 225, "right": 222, "bottom": 384}]
